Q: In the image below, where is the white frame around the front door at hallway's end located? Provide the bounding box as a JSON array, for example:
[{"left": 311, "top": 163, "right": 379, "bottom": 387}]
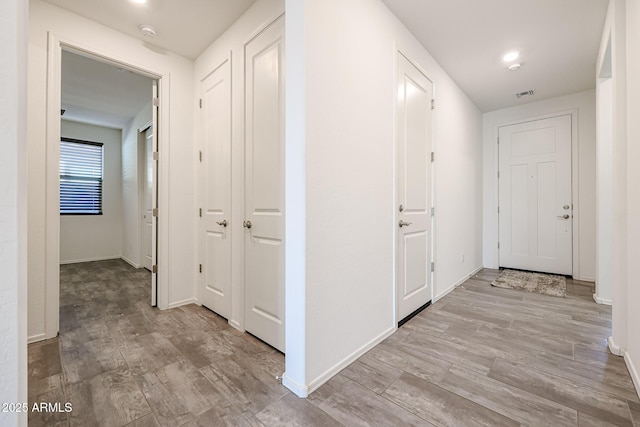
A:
[{"left": 491, "top": 109, "right": 581, "bottom": 278}]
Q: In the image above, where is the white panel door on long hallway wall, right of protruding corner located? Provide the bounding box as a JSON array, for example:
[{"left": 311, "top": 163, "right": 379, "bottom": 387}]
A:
[{"left": 396, "top": 53, "right": 433, "bottom": 321}]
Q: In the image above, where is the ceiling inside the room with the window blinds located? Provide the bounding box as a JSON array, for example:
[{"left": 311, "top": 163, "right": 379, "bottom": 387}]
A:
[{"left": 61, "top": 51, "right": 153, "bottom": 129}]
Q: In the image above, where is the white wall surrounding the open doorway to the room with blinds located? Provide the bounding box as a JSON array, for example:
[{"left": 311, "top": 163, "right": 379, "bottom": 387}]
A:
[{"left": 28, "top": 0, "right": 195, "bottom": 340}]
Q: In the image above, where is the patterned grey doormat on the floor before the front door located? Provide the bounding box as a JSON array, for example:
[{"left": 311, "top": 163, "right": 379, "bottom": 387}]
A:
[{"left": 491, "top": 269, "right": 567, "bottom": 298}]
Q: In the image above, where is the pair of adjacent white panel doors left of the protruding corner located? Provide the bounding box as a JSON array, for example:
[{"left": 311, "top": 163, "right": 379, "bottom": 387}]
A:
[{"left": 199, "top": 17, "right": 285, "bottom": 351}]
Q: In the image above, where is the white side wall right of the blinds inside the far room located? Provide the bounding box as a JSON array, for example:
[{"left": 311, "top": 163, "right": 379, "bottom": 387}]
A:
[{"left": 121, "top": 101, "right": 152, "bottom": 267}]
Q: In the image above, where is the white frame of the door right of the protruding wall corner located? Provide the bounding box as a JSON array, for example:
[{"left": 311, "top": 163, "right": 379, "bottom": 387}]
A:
[{"left": 392, "top": 48, "right": 437, "bottom": 328}]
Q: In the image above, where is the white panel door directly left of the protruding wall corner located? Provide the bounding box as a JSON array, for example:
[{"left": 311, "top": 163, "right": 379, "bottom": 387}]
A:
[{"left": 244, "top": 17, "right": 285, "bottom": 352}]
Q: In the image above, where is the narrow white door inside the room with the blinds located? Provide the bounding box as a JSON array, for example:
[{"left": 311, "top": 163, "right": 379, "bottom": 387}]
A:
[{"left": 142, "top": 126, "right": 153, "bottom": 271}]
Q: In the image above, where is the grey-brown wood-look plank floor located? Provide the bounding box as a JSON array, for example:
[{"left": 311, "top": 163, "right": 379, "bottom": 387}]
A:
[{"left": 29, "top": 261, "right": 640, "bottom": 427}]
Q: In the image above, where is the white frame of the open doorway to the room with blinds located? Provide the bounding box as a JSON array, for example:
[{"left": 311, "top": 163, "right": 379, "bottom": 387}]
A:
[{"left": 44, "top": 31, "right": 169, "bottom": 339}]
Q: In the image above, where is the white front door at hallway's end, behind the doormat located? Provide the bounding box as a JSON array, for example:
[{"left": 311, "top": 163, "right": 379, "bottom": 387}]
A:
[{"left": 498, "top": 115, "right": 573, "bottom": 275}]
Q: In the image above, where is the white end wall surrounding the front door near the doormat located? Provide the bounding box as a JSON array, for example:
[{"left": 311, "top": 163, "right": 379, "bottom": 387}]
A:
[{"left": 483, "top": 90, "right": 596, "bottom": 281}]
